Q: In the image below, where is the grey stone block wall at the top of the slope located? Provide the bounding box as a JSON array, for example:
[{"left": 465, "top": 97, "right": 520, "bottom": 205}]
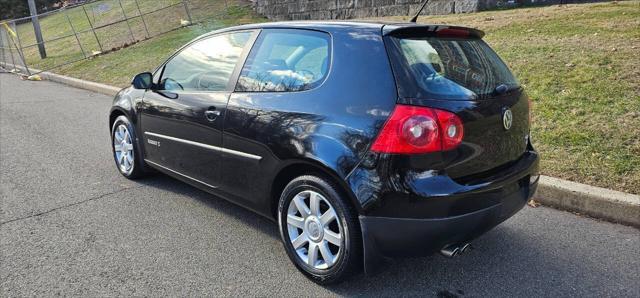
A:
[{"left": 253, "top": 0, "right": 587, "bottom": 20}]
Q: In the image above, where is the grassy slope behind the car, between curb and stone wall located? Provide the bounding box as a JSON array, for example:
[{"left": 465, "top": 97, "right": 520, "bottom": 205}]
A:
[{"left": 53, "top": 1, "right": 640, "bottom": 193}]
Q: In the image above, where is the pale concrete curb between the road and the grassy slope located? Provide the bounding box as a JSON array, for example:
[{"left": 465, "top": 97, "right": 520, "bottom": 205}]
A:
[{"left": 6, "top": 68, "right": 640, "bottom": 228}]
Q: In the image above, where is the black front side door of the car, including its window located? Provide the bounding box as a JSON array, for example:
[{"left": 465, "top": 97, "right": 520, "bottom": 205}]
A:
[{"left": 140, "top": 31, "right": 257, "bottom": 188}]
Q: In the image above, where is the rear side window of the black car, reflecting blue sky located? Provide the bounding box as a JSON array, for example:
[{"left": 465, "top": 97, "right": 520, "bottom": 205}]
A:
[{"left": 236, "top": 29, "right": 330, "bottom": 92}]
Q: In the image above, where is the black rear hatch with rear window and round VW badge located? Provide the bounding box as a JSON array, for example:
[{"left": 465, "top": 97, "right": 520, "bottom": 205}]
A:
[{"left": 383, "top": 25, "right": 529, "bottom": 182}]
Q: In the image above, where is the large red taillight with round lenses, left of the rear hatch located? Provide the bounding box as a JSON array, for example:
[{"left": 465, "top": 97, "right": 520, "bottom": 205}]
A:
[{"left": 371, "top": 105, "right": 464, "bottom": 154}]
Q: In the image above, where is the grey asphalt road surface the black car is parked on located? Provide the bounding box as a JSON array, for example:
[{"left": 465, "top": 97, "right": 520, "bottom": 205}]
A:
[{"left": 0, "top": 74, "right": 640, "bottom": 297}]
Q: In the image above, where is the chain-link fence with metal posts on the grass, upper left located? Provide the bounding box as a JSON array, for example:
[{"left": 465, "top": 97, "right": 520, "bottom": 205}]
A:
[{"left": 0, "top": 0, "right": 239, "bottom": 75}]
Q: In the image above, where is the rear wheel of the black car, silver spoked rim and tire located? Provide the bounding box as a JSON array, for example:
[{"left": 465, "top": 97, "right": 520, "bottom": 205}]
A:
[{"left": 278, "top": 175, "right": 362, "bottom": 285}]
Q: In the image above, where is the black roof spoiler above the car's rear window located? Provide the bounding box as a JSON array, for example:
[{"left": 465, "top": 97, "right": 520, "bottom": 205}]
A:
[{"left": 382, "top": 24, "right": 484, "bottom": 38}]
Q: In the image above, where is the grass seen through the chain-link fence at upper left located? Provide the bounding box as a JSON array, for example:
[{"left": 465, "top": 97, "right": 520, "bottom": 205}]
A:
[{"left": 8, "top": 0, "right": 252, "bottom": 69}]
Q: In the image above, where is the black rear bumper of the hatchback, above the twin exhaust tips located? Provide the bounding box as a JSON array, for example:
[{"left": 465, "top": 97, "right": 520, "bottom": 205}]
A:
[{"left": 360, "top": 151, "right": 538, "bottom": 274}]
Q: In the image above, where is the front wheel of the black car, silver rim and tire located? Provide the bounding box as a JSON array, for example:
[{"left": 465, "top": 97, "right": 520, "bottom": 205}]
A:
[{"left": 111, "top": 116, "right": 144, "bottom": 179}]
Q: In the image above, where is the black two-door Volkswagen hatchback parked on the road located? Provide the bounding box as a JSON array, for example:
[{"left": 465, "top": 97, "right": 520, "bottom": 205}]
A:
[{"left": 109, "top": 22, "right": 538, "bottom": 283}]
